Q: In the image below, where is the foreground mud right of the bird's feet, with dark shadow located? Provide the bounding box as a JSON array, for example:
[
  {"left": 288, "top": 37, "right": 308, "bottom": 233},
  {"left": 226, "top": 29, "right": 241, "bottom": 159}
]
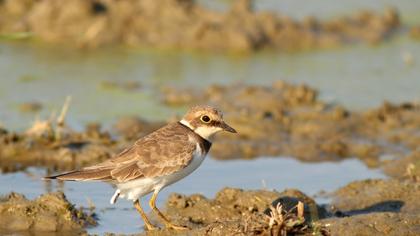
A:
[{"left": 133, "top": 180, "right": 420, "bottom": 235}]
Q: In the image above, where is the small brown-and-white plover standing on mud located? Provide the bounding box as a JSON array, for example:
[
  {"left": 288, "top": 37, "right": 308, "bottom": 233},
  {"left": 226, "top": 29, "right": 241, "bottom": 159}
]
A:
[{"left": 44, "top": 105, "right": 237, "bottom": 230}]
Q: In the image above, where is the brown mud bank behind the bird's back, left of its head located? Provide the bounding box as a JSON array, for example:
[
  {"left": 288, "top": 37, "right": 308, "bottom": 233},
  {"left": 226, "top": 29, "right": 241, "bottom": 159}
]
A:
[{"left": 0, "top": 109, "right": 162, "bottom": 173}]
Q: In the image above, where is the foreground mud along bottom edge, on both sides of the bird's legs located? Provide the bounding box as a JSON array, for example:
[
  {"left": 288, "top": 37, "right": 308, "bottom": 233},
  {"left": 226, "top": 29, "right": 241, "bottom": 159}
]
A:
[{"left": 0, "top": 179, "right": 420, "bottom": 235}]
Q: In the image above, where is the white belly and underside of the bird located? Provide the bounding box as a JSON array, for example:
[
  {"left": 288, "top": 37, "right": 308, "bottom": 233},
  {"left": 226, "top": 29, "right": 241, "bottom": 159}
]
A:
[{"left": 111, "top": 150, "right": 205, "bottom": 203}]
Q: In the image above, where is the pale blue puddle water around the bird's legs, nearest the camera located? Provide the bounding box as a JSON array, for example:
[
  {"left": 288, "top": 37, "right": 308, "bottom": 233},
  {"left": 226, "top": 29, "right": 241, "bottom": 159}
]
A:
[{"left": 0, "top": 158, "right": 385, "bottom": 234}]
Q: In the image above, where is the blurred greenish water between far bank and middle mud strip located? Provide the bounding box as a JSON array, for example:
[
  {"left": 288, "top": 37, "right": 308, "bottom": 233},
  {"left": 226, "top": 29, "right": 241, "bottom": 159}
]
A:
[{"left": 0, "top": 37, "right": 420, "bottom": 129}]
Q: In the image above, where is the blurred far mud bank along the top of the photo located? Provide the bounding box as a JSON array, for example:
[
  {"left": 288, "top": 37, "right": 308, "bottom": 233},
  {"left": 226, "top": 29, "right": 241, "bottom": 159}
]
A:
[{"left": 0, "top": 0, "right": 400, "bottom": 51}]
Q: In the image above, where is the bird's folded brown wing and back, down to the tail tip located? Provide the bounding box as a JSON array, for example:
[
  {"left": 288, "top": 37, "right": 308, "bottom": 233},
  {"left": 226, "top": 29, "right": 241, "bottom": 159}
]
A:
[{"left": 46, "top": 123, "right": 196, "bottom": 183}]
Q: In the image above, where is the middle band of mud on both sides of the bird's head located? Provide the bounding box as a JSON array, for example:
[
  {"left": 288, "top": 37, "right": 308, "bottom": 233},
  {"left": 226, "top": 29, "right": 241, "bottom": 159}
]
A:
[{"left": 0, "top": 81, "right": 420, "bottom": 177}]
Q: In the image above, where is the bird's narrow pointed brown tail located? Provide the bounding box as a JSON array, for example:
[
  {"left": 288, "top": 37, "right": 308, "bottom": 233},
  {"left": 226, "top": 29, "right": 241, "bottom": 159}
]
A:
[{"left": 44, "top": 169, "right": 112, "bottom": 181}]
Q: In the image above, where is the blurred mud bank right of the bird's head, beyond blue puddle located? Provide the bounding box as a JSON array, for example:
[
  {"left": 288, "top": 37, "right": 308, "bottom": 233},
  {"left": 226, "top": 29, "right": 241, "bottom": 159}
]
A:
[{"left": 163, "top": 81, "right": 420, "bottom": 167}]
